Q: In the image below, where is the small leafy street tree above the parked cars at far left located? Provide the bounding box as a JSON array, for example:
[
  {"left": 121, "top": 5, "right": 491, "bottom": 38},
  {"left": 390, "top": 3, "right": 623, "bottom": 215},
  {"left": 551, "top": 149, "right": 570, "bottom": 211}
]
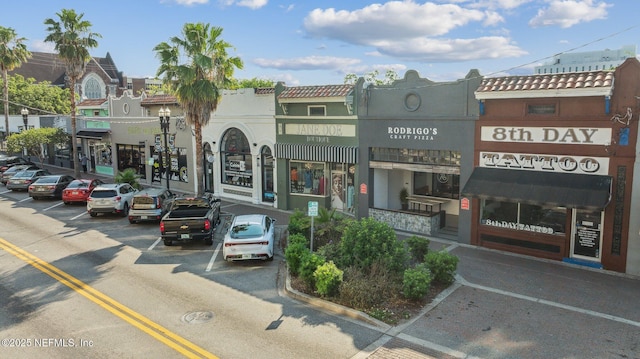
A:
[{"left": 7, "top": 127, "right": 69, "bottom": 166}]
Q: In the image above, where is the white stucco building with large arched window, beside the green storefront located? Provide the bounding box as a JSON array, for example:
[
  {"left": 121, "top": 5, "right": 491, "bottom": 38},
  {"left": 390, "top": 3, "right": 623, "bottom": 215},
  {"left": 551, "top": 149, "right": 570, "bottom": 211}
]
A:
[{"left": 202, "top": 88, "right": 276, "bottom": 205}]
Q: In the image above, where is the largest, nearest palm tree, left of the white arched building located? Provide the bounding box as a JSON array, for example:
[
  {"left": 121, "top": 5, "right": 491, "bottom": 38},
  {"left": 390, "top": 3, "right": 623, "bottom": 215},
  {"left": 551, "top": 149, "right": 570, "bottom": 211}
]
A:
[{"left": 153, "top": 23, "right": 243, "bottom": 195}]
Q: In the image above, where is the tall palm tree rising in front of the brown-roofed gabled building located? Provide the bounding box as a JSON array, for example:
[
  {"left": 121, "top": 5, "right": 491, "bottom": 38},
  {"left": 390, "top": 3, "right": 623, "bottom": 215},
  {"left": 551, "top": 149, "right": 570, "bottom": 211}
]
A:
[{"left": 44, "top": 9, "right": 102, "bottom": 178}]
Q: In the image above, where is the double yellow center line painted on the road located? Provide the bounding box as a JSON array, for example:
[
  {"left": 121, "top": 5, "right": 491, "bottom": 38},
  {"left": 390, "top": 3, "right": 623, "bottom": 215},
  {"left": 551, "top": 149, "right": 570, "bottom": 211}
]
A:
[{"left": 0, "top": 238, "right": 217, "bottom": 358}]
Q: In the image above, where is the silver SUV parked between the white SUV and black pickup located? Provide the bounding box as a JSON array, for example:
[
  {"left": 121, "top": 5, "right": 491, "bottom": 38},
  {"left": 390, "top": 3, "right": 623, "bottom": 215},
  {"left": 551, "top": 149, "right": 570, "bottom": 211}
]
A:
[{"left": 129, "top": 188, "right": 176, "bottom": 223}]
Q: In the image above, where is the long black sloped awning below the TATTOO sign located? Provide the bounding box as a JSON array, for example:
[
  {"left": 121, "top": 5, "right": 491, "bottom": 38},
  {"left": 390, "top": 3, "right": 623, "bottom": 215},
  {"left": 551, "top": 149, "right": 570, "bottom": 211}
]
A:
[{"left": 461, "top": 167, "right": 612, "bottom": 209}]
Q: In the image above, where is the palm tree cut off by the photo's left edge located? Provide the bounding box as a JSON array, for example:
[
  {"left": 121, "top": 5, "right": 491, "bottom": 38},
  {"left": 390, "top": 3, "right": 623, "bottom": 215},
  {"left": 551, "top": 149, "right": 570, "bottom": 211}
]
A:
[{"left": 0, "top": 26, "right": 31, "bottom": 141}]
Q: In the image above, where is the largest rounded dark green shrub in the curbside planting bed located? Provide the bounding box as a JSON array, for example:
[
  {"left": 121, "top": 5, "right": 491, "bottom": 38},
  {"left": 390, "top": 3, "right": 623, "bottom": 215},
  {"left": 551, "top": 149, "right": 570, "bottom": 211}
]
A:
[{"left": 338, "top": 217, "right": 407, "bottom": 273}]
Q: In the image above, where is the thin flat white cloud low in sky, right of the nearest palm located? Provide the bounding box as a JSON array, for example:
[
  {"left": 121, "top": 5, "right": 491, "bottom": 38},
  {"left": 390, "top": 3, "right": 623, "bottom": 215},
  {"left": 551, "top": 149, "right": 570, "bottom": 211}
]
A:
[{"left": 252, "top": 56, "right": 361, "bottom": 70}]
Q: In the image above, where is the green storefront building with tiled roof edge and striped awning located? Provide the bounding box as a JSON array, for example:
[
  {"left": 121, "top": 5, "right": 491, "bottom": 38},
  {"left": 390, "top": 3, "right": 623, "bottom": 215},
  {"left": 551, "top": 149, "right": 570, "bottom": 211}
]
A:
[{"left": 275, "top": 83, "right": 358, "bottom": 215}]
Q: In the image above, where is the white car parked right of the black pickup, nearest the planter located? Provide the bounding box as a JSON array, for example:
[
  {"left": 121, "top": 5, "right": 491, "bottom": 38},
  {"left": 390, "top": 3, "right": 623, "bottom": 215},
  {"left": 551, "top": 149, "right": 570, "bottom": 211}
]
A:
[{"left": 222, "top": 214, "right": 276, "bottom": 261}]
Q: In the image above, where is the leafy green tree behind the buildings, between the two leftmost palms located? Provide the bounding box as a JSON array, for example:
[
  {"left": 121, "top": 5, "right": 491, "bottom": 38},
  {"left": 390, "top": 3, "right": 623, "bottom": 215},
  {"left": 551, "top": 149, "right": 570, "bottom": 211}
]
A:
[{"left": 3, "top": 74, "right": 71, "bottom": 114}]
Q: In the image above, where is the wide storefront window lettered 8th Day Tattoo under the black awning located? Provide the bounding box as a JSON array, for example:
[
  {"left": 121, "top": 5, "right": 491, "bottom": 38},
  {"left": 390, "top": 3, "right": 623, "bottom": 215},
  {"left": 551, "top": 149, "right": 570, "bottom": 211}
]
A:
[{"left": 480, "top": 199, "right": 567, "bottom": 235}]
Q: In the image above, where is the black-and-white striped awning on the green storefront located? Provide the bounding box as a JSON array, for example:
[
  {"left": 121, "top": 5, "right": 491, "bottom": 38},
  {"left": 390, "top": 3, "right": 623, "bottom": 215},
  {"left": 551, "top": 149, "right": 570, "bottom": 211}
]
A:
[{"left": 275, "top": 143, "right": 358, "bottom": 163}]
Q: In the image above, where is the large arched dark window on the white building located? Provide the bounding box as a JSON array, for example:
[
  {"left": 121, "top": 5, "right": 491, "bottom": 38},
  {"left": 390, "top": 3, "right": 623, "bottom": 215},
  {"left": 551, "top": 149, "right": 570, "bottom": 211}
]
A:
[{"left": 220, "top": 128, "right": 253, "bottom": 187}]
